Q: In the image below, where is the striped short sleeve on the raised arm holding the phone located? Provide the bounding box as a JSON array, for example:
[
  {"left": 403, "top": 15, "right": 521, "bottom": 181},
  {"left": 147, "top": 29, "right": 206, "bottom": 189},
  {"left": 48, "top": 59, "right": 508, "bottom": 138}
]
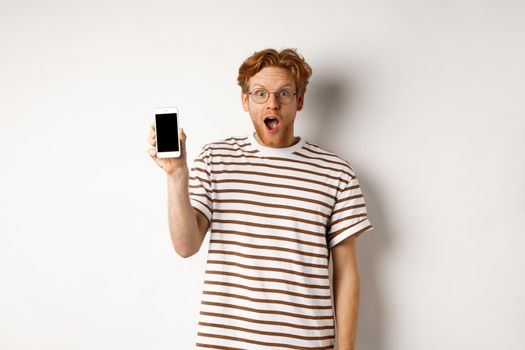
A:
[{"left": 188, "top": 146, "right": 213, "bottom": 227}]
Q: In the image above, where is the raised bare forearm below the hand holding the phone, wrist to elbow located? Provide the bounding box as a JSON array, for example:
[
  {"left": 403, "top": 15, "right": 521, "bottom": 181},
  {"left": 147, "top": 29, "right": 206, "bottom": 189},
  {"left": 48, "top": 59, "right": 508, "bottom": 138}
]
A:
[{"left": 168, "top": 170, "right": 201, "bottom": 257}]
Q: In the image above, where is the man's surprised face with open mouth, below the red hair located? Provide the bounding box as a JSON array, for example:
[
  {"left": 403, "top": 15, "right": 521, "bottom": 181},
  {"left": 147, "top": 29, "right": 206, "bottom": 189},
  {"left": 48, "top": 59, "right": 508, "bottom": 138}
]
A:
[{"left": 241, "top": 67, "right": 304, "bottom": 147}]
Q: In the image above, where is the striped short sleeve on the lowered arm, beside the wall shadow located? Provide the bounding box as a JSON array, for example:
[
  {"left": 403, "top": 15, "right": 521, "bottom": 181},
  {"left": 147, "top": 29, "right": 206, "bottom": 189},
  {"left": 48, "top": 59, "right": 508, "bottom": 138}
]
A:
[{"left": 327, "top": 172, "right": 373, "bottom": 249}]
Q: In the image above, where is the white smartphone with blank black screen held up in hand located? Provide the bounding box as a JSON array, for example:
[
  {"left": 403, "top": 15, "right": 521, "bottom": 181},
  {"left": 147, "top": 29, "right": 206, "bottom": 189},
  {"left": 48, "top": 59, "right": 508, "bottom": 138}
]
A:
[{"left": 155, "top": 107, "right": 181, "bottom": 158}]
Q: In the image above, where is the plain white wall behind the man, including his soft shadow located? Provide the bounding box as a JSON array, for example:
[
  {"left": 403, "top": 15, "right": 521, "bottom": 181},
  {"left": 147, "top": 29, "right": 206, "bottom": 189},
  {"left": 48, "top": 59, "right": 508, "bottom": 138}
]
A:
[{"left": 0, "top": 0, "right": 525, "bottom": 350}]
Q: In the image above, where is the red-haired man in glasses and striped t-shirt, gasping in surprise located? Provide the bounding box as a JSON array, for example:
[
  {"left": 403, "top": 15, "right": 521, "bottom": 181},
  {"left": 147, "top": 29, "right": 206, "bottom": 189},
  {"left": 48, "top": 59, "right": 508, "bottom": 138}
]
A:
[{"left": 149, "top": 49, "right": 373, "bottom": 350}]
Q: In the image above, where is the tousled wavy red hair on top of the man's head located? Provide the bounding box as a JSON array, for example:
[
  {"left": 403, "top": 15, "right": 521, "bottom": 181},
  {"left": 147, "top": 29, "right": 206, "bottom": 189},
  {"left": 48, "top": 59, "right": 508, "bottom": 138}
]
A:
[{"left": 237, "top": 49, "right": 312, "bottom": 96}]
